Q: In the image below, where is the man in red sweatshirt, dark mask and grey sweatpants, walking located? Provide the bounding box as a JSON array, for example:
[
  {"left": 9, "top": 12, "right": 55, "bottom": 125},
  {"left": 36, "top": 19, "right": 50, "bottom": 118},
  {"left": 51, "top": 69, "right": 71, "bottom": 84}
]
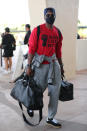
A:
[{"left": 27, "top": 8, "right": 64, "bottom": 128}]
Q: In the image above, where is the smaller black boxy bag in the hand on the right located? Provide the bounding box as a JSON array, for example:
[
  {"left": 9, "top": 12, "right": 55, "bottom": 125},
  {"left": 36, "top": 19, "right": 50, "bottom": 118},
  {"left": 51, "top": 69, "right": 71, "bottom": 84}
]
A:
[{"left": 59, "top": 80, "right": 73, "bottom": 101}]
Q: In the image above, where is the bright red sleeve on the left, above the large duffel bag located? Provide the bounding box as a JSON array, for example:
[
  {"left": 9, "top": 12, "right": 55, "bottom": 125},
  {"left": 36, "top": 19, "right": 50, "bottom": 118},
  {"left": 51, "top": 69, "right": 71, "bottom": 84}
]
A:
[{"left": 28, "top": 28, "right": 37, "bottom": 55}]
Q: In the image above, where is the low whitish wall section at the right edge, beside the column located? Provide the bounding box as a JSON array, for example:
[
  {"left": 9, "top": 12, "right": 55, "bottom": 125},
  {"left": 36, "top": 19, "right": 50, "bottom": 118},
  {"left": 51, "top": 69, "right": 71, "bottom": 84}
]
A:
[{"left": 76, "top": 40, "right": 87, "bottom": 71}]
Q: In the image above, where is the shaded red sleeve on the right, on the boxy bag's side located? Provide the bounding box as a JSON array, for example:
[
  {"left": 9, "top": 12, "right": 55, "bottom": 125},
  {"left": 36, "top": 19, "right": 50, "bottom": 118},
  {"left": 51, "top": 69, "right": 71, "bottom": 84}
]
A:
[{"left": 56, "top": 34, "right": 63, "bottom": 58}]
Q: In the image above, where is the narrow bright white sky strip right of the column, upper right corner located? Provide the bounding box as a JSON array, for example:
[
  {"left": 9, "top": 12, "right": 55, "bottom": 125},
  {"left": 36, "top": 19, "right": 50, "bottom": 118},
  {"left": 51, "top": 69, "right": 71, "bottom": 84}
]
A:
[{"left": 78, "top": 0, "right": 87, "bottom": 25}]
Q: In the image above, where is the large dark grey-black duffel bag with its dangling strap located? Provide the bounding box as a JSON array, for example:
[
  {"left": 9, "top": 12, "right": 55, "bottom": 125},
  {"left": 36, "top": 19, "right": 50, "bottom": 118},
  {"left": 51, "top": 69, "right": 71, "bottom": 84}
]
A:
[{"left": 11, "top": 77, "right": 43, "bottom": 126}]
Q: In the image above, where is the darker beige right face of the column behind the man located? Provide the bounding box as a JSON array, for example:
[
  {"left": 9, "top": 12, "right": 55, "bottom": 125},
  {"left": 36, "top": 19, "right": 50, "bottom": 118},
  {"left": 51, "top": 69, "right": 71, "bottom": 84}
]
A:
[{"left": 46, "top": 0, "right": 79, "bottom": 78}]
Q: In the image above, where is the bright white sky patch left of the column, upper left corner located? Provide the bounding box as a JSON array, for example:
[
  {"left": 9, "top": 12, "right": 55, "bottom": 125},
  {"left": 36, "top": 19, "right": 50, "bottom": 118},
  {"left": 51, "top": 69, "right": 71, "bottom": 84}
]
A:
[{"left": 0, "top": 0, "right": 30, "bottom": 24}]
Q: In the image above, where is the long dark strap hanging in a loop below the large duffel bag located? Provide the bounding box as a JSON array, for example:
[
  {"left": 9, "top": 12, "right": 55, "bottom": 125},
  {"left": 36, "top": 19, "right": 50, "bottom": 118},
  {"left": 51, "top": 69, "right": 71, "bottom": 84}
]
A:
[{"left": 19, "top": 102, "right": 42, "bottom": 126}]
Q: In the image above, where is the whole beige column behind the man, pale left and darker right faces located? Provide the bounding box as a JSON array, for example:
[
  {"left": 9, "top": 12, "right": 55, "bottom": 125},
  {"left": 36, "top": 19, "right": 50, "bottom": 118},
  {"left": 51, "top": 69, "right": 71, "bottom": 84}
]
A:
[{"left": 29, "top": 0, "right": 79, "bottom": 78}]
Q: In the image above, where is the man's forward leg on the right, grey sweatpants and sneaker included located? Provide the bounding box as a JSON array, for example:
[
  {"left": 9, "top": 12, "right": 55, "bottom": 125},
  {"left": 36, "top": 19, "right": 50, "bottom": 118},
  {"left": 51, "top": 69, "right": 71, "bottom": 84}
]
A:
[{"left": 47, "top": 63, "right": 61, "bottom": 128}]
